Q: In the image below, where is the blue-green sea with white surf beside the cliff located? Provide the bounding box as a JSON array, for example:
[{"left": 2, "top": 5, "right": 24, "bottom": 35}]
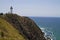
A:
[{"left": 30, "top": 17, "right": 60, "bottom": 40}]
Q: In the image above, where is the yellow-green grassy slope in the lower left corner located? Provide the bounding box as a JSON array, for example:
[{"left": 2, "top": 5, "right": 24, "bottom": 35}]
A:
[{"left": 0, "top": 18, "right": 25, "bottom": 40}]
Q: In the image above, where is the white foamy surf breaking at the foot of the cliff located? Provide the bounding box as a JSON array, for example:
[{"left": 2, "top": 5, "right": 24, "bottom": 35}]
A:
[{"left": 40, "top": 27, "right": 56, "bottom": 40}]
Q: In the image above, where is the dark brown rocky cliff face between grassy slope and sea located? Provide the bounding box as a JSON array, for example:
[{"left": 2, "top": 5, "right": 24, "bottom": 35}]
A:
[{"left": 1, "top": 14, "right": 46, "bottom": 40}]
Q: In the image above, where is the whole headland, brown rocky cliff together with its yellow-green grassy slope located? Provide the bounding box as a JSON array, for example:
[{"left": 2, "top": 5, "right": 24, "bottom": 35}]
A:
[{"left": 0, "top": 14, "right": 46, "bottom": 40}]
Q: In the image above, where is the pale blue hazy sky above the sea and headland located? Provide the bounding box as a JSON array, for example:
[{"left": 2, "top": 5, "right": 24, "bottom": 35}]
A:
[{"left": 0, "top": 0, "right": 60, "bottom": 17}]
